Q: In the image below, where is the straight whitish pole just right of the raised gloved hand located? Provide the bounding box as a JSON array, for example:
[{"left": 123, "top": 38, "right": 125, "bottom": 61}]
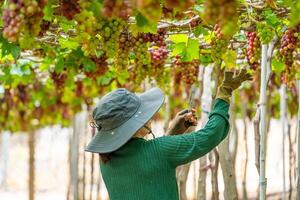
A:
[{"left": 259, "top": 44, "right": 268, "bottom": 200}]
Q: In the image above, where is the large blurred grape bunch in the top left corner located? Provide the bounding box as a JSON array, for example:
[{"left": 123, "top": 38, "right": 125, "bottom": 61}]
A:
[{"left": 3, "top": 0, "right": 47, "bottom": 42}]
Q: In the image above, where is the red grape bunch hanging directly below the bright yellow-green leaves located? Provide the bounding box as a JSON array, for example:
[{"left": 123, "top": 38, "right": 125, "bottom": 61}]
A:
[{"left": 174, "top": 56, "right": 199, "bottom": 85}]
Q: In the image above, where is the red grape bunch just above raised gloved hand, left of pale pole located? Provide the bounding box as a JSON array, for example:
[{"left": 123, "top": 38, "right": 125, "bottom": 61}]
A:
[{"left": 246, "top": 31, "right": 260, "bottom": 70}]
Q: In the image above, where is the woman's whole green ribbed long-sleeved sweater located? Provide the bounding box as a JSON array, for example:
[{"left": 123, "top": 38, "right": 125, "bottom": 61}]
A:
[{"left": 100, "top": 99, "right": 229, "bottom": 200}]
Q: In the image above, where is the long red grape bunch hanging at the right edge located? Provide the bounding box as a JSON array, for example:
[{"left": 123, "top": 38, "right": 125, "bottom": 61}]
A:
[{"left": 279, "top": 24, "right": 300, "bottom": 88}]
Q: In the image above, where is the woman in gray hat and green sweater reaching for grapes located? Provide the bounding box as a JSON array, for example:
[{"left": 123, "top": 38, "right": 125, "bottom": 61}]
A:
[{"left": 86, "top": 70, "right": 251, "bottom": 200}]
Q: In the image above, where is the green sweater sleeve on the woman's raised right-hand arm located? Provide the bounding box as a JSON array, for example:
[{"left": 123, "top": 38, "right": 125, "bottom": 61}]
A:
[{"left": 153, "top": 99, "right": 229, "bottom": 166}]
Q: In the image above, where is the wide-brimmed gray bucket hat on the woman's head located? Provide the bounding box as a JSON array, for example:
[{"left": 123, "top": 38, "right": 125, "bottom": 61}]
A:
[{"left": 85, "top": 88, "right": 164, "bottom": 153}]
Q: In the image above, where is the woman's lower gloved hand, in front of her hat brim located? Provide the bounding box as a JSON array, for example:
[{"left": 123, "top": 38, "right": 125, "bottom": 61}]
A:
[{"left": 166, "top": 109, "right": 197, "bottom": 135}]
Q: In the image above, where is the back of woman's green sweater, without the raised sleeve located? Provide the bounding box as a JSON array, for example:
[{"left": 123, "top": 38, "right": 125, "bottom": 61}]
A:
[{"left": 101, "top": 138, "right": 178, "bottom": 200}]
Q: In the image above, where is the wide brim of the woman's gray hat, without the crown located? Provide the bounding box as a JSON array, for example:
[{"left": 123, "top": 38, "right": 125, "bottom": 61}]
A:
[{"left": 85, "top": 88, "right": 165, "bottom": 153}]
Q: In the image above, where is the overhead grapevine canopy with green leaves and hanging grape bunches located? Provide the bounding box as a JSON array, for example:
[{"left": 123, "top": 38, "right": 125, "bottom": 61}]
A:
[{"left": 0, "top": 0, "right": 300, "bottom": 131}]
